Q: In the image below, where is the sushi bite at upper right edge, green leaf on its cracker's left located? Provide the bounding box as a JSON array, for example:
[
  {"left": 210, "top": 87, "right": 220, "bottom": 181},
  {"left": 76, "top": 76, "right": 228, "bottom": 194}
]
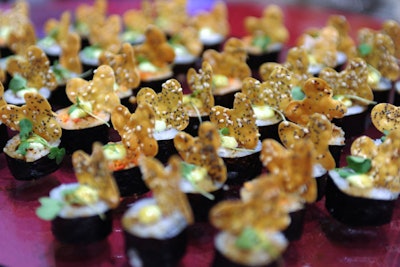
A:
[{"left": 357, "top": 28, "right": 400, "bottom": 103}]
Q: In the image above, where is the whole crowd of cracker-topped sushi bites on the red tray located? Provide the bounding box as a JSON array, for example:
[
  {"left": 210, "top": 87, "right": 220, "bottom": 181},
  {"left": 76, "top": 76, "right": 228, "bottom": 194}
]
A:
[{"left": 0, "top": 1, "right": 400, "bottom": 266}]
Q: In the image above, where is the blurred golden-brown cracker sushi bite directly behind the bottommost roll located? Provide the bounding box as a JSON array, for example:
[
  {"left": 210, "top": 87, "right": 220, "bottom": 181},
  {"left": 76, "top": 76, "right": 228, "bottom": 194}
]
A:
[{"left": 260, "top": 138, "right": 318, "bottom": 241}]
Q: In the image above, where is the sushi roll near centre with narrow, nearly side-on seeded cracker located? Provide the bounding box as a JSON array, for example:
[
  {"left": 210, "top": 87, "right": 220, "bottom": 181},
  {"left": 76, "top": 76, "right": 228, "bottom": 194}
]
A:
[{"left": 183, "top": 61, "right": 214, "bottom": 136}]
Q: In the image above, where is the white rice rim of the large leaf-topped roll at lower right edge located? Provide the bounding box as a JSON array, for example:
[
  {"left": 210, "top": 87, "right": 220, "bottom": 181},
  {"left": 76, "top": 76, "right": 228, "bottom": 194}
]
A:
[{"left": 329, "top": 170, "right": 399, "bottom": 200}]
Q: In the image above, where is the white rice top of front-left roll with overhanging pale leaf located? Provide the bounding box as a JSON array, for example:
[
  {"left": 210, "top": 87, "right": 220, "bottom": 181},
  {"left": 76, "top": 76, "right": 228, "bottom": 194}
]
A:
[{"left": 49, "top": 183, "right": 110, "bottom": 219}]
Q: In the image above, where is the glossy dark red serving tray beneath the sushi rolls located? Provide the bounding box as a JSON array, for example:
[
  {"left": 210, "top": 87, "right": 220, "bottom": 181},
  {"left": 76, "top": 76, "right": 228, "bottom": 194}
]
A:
[{"left": 0, "top": 0, "right": 400, "bottom": 267}]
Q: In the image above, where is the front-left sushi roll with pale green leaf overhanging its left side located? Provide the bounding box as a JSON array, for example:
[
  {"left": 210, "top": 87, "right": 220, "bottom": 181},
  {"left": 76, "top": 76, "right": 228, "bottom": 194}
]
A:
[{"left": 36, "top": 143, "right": 119, "bottom": 245}]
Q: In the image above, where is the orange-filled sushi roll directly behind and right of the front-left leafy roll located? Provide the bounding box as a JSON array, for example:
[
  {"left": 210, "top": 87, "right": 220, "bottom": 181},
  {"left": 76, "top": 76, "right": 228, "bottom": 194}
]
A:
[{"left": 103, "top": 103, "right": 158, "bottom": 197}]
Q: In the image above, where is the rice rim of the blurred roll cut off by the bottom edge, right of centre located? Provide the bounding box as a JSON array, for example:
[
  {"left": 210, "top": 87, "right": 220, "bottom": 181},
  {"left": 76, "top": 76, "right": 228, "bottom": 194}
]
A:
[{"left": 214, "top": 232, "right": 288, "bottom": 266}]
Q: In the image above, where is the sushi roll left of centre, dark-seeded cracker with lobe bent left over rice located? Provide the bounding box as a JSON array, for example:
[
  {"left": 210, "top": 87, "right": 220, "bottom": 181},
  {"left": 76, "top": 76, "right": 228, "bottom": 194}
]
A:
[{"left": 136, "top": 79, "right": 189, "bottom": 163}]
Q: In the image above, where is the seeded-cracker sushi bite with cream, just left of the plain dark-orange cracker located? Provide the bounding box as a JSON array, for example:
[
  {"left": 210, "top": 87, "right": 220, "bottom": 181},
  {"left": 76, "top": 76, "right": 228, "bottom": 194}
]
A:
[{"left": 242, "top": 64, "right": 293, "bottom": 140}]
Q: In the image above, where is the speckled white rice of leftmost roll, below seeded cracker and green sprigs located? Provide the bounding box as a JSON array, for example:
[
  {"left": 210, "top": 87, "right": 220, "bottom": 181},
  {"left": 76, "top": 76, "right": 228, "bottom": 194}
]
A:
[{"left": 3, "top": 135, "right": 61, "bottom": 162}]
